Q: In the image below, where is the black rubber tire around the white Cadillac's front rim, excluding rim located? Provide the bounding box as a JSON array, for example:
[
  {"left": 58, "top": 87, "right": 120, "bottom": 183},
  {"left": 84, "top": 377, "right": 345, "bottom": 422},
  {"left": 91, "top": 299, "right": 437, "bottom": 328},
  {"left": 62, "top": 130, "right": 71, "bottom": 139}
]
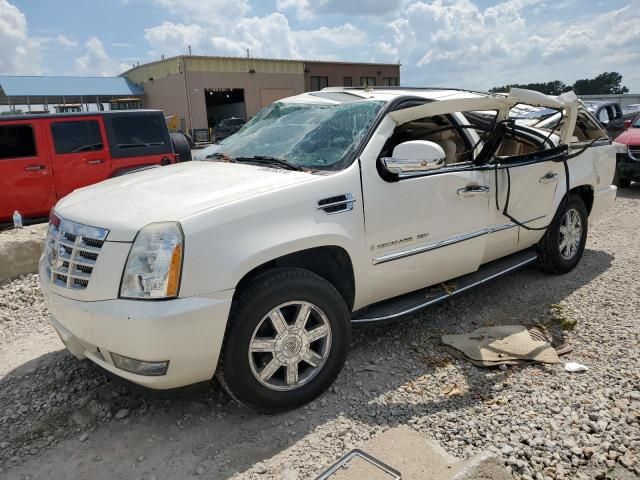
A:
[{"left": 222, "top": 269, "right": 351, "bottom": 411}]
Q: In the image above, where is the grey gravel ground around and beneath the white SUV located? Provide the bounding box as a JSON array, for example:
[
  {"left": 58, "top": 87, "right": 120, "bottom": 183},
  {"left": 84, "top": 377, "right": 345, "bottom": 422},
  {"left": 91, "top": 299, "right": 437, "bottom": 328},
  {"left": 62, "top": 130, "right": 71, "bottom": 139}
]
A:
[{"left": 0, "top": 184, "right": 640, "bottom": 480}]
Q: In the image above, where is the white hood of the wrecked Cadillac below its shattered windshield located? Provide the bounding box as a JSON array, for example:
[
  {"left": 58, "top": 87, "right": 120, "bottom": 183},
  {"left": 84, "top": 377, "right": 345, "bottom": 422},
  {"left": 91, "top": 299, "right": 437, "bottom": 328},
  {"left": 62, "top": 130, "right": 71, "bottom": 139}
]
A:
[{"left": 55, "top": 162, "right": 315, "bottom": 242}]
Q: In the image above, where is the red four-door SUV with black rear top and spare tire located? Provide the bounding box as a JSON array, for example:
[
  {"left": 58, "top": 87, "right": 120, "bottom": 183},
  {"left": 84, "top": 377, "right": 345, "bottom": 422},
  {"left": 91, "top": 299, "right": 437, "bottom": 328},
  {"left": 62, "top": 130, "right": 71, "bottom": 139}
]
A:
[{"left": 0, "top": 110, "right": 191, "bottom": 224}]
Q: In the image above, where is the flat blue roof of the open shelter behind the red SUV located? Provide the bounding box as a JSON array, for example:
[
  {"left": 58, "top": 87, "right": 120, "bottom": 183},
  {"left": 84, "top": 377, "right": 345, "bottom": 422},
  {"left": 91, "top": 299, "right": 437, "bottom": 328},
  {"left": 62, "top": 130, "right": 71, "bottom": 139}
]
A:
[{"left": 0, "top": 75, "right": 144, "bottom": 97}]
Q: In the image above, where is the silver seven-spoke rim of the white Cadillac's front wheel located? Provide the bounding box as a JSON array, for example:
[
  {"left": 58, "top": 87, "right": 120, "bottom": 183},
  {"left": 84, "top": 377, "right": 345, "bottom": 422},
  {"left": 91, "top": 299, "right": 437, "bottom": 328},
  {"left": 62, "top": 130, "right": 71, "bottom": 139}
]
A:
[{"left": 249, "top": 301, "right": 331, "bottom": 391}]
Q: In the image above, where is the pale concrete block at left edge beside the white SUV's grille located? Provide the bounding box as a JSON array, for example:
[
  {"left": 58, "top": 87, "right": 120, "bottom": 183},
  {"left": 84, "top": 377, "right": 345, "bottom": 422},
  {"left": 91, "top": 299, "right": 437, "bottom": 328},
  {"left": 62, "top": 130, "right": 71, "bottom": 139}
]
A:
[{"left": 0, "top": 223, "right": 47, "bottom": 283}]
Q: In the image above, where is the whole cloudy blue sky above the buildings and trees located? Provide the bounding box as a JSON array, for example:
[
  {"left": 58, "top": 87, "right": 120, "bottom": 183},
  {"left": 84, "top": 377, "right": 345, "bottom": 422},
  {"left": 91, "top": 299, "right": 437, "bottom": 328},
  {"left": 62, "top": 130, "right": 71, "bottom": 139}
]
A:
[{"left": 0, "top": 0, "right": 640, "bottom": 93}]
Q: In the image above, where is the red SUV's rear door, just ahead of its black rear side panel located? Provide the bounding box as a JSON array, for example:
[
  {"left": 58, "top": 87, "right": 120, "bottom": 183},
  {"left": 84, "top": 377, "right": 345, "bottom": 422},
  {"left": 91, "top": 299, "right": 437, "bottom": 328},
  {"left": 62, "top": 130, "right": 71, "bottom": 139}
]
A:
[{"left": 48, "top": 116, "right": 111, "bottom": 198}]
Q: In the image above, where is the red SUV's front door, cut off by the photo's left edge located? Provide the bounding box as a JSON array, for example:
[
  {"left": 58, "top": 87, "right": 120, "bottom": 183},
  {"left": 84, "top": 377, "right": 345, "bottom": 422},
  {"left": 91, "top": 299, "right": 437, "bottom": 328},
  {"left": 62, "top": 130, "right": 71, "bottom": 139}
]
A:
[{"left": 0, "top": 120, "right": 55, "bottom": 222}]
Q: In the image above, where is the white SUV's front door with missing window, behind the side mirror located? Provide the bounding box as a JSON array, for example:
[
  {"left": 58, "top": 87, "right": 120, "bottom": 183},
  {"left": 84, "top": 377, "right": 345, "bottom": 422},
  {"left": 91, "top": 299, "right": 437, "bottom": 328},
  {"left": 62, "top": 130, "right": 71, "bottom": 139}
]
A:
[{"left": 360, "top": 101, "right": 502, "bottom": 306}]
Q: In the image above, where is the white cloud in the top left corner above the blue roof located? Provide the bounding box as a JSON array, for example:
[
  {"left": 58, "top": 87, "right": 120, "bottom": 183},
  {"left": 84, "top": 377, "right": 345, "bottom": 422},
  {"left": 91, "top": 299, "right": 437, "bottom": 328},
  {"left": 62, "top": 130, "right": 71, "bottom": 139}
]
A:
[{"left": 0, "top": 0, "right": 42, "bottom": 75}]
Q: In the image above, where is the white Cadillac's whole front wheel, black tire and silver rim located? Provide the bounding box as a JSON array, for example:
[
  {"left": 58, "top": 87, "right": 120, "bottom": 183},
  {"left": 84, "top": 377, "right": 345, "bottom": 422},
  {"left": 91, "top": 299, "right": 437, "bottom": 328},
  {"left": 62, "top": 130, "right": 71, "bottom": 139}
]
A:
[{"left": 218, "top": 268, "right": 351, "bottom": 411}]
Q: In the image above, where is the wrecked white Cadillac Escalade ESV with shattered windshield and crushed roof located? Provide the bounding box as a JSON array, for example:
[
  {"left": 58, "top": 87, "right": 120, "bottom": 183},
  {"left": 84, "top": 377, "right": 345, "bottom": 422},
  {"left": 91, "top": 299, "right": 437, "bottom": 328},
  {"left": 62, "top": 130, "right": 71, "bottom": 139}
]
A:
[{"left": 39, "top": 88, "right": 616, "bottom": 410}]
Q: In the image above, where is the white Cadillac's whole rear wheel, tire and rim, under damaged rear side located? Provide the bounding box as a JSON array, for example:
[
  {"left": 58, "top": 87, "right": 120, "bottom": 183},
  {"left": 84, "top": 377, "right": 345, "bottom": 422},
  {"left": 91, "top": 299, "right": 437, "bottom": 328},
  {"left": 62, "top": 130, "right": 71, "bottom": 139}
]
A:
[{"left": 538, "top": 194, "right": 589, "bottom": 273}]
